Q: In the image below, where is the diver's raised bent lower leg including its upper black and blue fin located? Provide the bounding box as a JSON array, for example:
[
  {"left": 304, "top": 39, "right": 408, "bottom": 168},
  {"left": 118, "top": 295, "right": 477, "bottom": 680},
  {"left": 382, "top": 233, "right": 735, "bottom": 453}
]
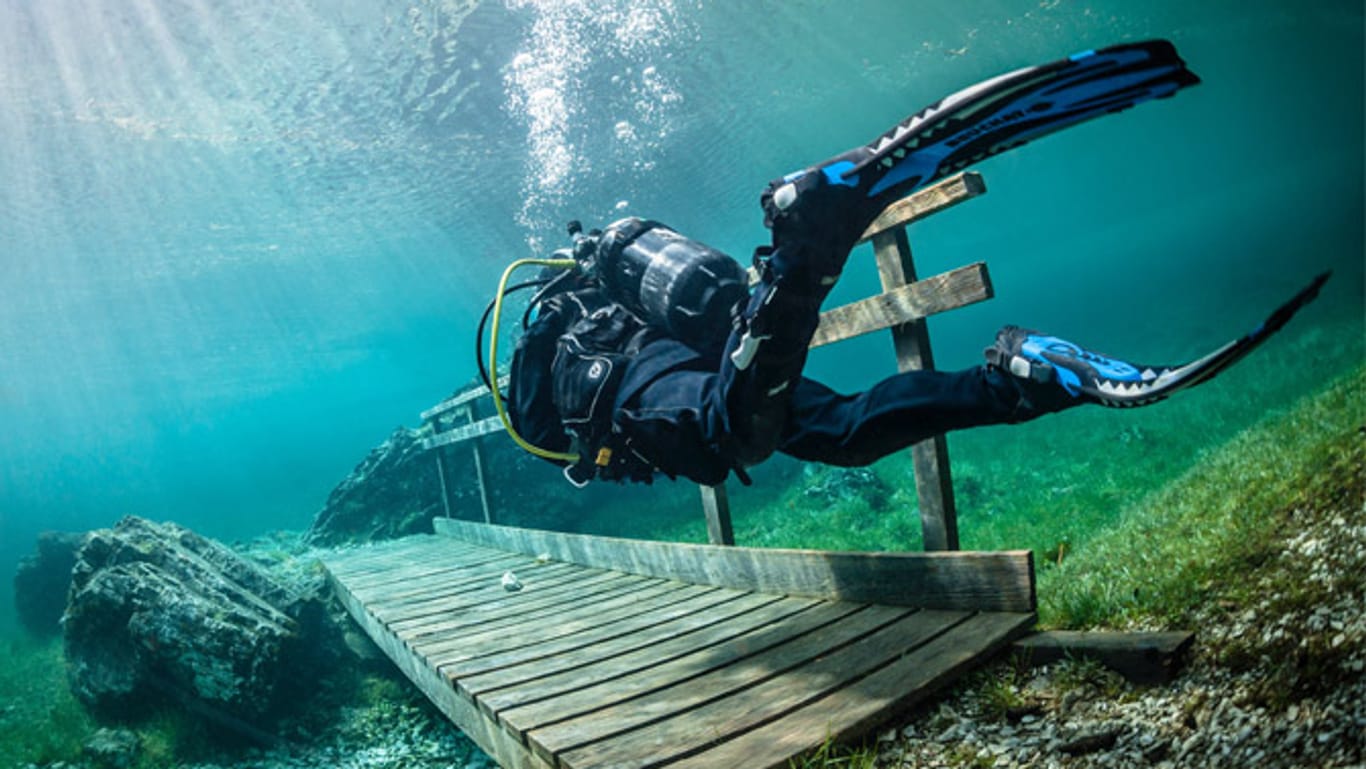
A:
[{"left": 720, "top": 41, "right": 1199, "bottom": 464}]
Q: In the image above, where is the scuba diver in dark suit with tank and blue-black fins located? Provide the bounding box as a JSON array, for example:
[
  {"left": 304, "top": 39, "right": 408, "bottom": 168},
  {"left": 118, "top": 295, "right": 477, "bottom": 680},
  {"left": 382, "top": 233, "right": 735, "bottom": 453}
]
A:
[{"left": 477, "top": 41, "right": 1328, "bottom": 485}]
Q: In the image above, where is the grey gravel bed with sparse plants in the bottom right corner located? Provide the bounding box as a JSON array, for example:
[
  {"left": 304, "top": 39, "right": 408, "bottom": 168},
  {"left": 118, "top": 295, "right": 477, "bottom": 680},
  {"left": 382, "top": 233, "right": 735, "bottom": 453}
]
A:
[{"left": 876, "top": 509, "right": 1366, "bottom": 769}]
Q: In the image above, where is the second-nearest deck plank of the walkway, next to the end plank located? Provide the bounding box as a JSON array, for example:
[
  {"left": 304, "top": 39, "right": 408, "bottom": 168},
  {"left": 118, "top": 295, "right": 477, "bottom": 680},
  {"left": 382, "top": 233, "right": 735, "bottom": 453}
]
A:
[{"left": 556, "top": 612, "right": 971, "bottom": 768}]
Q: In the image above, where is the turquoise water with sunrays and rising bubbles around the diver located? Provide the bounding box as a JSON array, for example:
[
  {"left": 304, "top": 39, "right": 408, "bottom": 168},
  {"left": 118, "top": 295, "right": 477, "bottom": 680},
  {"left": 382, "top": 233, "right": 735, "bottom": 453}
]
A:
[{"left": 0, "top": 0, "right": 1363, "bottom": 639}]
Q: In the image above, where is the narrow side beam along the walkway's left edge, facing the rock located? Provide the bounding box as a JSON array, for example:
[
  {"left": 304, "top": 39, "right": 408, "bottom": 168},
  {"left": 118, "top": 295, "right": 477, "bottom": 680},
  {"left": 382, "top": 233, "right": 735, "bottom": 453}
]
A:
[{"left": 328, "top": 562, "right": 555, "bottom": 769}]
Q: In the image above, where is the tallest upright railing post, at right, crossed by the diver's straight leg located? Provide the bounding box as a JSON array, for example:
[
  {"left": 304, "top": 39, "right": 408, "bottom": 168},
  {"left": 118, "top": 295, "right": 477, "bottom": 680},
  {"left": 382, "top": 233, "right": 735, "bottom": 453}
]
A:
[{"left": 873, "top": 227, "right": 959, "bottom": 550}]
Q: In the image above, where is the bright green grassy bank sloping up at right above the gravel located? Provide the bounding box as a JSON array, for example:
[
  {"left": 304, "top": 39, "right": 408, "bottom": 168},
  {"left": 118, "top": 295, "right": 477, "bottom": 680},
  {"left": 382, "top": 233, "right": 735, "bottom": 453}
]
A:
[{"left": 1040, "top": 367, "right": 1366, "bottom": 627}]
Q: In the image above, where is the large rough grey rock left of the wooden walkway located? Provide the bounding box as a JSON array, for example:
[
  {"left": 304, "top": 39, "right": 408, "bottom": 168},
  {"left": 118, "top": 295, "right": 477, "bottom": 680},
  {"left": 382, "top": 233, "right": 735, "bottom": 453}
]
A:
[{"left": 63, "top": 516, "right": 340, "bottom": 725}]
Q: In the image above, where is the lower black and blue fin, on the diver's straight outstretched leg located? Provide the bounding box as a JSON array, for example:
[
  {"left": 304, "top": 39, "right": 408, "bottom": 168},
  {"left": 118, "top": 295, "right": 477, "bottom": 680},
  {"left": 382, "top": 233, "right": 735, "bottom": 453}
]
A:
[{"left": 986, "top": 272, "right": 1330, "bottom": 410}]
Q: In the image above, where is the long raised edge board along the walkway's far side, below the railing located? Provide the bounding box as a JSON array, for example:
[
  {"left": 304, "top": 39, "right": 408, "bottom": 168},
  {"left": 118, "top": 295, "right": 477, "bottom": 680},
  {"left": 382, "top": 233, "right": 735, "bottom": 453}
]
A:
[{"left": 433, "top": 518, "right": 1035, "bottom": 612}]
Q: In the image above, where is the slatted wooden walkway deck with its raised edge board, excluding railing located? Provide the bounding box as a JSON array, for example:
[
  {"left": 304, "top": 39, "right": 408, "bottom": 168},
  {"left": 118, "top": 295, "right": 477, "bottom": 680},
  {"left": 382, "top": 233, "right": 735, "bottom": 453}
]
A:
[{"left": 324, "top": 519, "right": 1034, "bottom": 768}]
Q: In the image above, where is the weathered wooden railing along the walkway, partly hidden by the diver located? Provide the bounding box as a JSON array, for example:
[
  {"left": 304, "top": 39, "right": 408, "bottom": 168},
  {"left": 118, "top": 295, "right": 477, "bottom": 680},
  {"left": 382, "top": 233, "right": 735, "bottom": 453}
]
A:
[{"left": 422, "top": 172, "right": 993, "bottom": 550}]
